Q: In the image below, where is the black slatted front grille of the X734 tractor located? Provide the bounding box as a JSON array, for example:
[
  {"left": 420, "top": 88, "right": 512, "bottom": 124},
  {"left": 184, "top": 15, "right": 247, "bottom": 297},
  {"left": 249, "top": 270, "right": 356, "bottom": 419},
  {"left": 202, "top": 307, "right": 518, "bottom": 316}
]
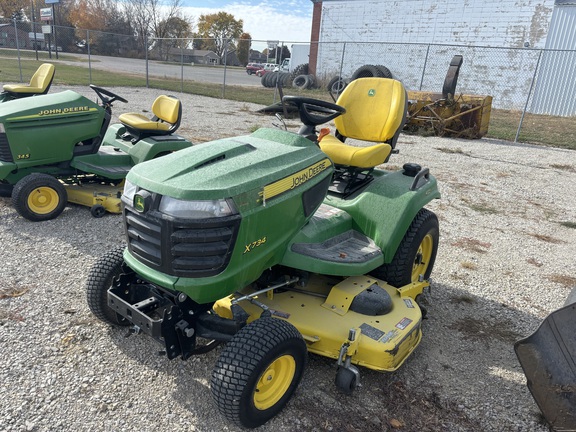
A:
[{"left": 124, "top": 206, "right": 240, "bottom": 277}]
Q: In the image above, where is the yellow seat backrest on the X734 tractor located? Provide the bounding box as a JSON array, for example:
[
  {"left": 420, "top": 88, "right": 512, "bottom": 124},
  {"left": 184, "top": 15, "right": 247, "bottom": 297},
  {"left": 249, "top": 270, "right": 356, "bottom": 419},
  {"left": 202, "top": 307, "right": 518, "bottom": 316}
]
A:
[{"left": 334, "top": 78, "right": 407, "bottom": 143}]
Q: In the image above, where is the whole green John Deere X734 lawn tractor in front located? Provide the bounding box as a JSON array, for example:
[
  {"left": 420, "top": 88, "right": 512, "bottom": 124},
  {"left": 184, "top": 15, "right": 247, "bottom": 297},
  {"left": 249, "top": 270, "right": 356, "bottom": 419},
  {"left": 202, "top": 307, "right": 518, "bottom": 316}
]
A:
[{"left": 86, "top": 78, "right": 440, "bottom": 428}]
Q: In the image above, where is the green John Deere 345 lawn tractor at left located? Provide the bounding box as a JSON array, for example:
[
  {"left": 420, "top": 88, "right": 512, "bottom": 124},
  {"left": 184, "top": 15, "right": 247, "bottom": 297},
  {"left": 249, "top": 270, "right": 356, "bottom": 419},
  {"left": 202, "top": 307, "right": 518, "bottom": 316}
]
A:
[{"left": 0, "top": 85, "right": 192, "bottom": 221}]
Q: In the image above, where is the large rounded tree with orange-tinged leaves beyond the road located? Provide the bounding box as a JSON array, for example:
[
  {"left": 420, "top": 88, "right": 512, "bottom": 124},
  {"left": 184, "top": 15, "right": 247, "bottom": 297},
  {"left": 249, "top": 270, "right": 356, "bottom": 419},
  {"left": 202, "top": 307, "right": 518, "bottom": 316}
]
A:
[{"left": 196, "top": 12, "right": 244, "bottom": 58}]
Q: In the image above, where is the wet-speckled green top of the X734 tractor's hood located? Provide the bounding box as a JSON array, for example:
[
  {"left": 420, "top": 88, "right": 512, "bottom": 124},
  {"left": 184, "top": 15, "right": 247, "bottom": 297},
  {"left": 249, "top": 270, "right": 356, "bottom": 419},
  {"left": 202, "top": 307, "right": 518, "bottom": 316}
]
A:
[{"left": 127, "top": 129, "right": 332, "bottom": 200}]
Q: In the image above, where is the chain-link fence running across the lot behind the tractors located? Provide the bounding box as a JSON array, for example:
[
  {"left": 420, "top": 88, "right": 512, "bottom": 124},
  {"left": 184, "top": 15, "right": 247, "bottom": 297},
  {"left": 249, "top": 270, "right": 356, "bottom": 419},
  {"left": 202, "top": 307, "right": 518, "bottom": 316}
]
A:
[{"left": 0, "top": 19, "right": 576, "bottom": 143}]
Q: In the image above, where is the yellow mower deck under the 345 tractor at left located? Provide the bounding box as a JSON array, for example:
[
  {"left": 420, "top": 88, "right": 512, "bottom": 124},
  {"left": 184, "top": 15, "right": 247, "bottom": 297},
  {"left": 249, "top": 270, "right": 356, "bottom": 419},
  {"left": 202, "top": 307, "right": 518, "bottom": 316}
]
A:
[{"left": 66, "top": 182, "right": 124, "bottom": 213}]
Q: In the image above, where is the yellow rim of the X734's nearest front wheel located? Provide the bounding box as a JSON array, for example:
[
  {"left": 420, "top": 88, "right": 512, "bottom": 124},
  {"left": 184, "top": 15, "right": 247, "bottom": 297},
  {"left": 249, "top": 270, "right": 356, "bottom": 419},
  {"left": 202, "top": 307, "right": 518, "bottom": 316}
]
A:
[{"left": 254, "top": 355, "right": 296, "bottom": 410}]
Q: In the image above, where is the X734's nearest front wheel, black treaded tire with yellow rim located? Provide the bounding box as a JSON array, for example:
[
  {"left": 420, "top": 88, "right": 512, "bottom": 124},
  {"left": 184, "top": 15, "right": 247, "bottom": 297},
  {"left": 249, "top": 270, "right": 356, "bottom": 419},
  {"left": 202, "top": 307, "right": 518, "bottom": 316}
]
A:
[{"left": 211, "top": 318, "right": 307, "bottom": 428}]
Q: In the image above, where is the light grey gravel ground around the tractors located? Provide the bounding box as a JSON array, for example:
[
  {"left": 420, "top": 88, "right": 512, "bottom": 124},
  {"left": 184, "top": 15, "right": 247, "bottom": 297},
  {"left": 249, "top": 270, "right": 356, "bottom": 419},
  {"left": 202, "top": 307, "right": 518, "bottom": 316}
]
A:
[{"left": 0, "top": 87, "right": 576, "bottom": 432}]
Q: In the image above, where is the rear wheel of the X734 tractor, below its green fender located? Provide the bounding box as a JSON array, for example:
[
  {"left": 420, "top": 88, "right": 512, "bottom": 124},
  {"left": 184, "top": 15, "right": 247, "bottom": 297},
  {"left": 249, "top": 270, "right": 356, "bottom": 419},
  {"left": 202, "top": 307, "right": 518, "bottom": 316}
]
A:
[{"left": 370, "top": 209, "right": 440, "bottom": 288}]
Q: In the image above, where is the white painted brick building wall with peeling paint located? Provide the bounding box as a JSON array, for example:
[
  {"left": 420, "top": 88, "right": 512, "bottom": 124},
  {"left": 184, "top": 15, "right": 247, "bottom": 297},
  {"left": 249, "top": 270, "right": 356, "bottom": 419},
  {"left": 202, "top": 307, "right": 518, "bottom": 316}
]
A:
[{"left": 316, "top": 0, "right": 568, "bottom": 110}]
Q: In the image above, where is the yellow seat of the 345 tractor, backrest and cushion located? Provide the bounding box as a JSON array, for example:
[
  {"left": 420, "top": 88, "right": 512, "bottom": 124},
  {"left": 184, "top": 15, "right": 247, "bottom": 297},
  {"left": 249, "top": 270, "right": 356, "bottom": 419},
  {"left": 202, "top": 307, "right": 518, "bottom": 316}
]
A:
[{"left": 118, "top": 95, "right": 182, "bottom": 139}]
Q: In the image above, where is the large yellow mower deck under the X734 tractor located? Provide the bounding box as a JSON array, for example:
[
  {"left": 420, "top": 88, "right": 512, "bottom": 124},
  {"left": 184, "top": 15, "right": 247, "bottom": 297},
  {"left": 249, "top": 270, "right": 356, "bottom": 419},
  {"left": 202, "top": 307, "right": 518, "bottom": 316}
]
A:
[{"left": 214, "top": 276, "right": 429, "bottom": 371}]
